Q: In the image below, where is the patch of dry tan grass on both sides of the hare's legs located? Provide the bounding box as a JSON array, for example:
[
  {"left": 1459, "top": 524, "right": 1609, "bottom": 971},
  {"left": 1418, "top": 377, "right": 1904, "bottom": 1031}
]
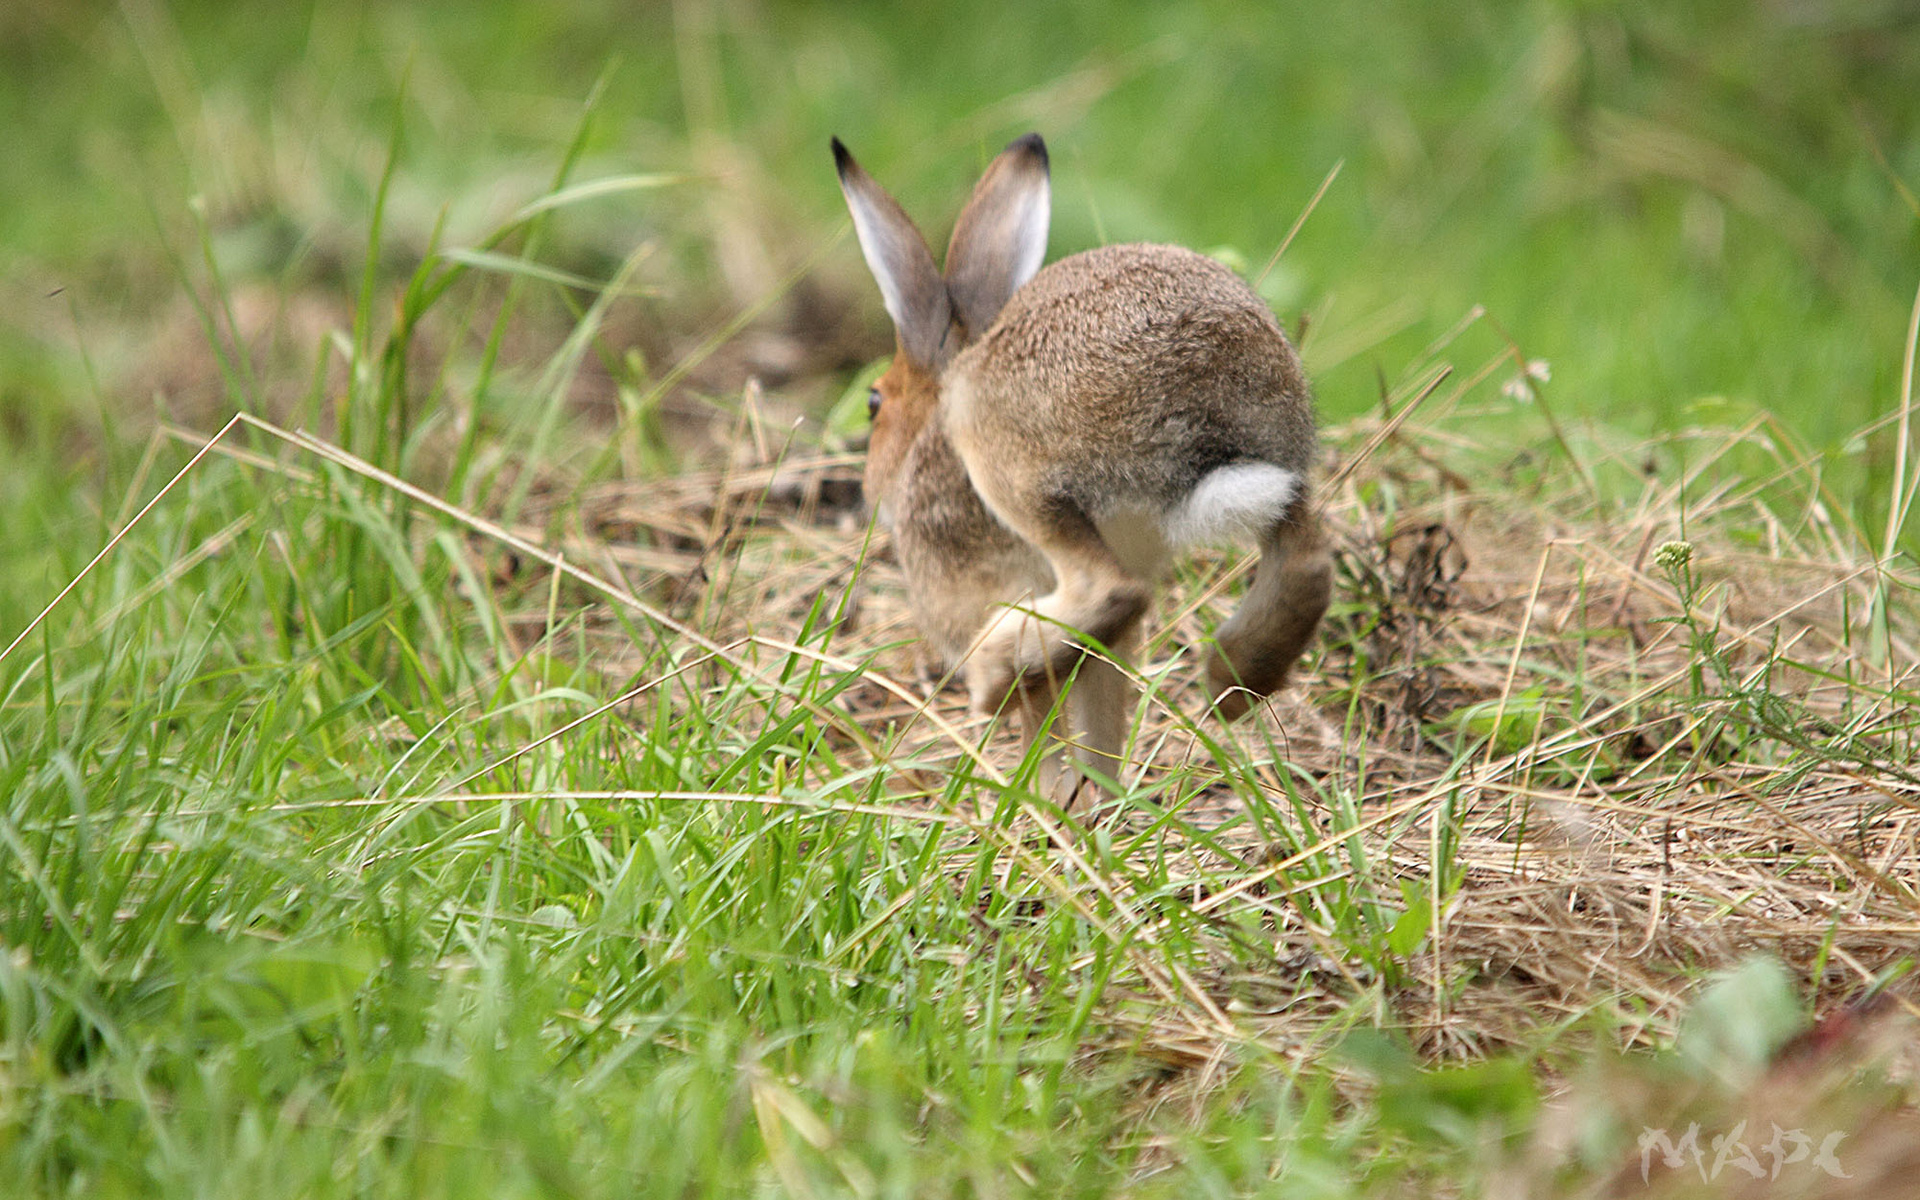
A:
[{"left": 510, "top": 366, "right": 1920, "bottom": 1066}]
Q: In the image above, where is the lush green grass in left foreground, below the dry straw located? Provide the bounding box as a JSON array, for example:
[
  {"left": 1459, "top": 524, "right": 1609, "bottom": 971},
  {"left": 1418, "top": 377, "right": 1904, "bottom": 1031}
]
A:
[{"left": 0, "top": 399, "right": 1443, "bottom": 1196}]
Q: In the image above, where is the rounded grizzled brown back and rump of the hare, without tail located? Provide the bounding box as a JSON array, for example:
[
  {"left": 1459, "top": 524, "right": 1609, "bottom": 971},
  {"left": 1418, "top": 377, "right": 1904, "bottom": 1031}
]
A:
[{"left": 945, "top": 246, "right": 1313, "bottom": 511}]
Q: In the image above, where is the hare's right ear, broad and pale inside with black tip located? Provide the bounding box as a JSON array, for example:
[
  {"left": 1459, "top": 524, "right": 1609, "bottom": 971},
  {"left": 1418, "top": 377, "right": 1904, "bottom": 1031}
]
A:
[{"left": 947, "top": 132, "right": 1052, "bottom": 338}]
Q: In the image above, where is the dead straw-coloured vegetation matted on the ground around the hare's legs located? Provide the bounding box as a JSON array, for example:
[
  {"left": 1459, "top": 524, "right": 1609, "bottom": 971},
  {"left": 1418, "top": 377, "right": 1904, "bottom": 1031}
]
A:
[{"left": 145, "top": 295, "right": 1920, "bottom": 1194}]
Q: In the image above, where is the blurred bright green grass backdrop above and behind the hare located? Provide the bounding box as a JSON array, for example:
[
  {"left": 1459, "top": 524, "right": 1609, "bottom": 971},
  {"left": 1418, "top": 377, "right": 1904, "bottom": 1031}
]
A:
[{"left": 0, "top": 0, "right": 1920, "bottom": 520}]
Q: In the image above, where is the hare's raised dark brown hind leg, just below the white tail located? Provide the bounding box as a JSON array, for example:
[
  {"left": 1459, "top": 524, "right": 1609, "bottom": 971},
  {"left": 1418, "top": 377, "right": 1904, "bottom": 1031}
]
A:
[{"left": 1208, "top": 495, "right": 1332, "bottom": 720}]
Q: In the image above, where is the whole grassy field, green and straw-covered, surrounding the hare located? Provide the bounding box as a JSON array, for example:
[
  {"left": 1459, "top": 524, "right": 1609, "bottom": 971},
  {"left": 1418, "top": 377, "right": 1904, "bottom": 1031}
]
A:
[{"left": 0, "top": 2, "right": 1920, "bottom": 1196}]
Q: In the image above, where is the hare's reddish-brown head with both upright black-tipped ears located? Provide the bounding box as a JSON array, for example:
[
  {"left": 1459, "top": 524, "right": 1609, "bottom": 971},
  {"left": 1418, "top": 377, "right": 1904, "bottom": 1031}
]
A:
[{"left": 833, "top": 134, "right": 1048, "bottom": 507}]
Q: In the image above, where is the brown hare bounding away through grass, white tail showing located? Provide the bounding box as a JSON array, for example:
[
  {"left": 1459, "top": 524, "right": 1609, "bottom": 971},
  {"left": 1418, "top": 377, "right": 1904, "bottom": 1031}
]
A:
[{"left": 833, "top": 134, "right": 1331, "bottom": 794}]
